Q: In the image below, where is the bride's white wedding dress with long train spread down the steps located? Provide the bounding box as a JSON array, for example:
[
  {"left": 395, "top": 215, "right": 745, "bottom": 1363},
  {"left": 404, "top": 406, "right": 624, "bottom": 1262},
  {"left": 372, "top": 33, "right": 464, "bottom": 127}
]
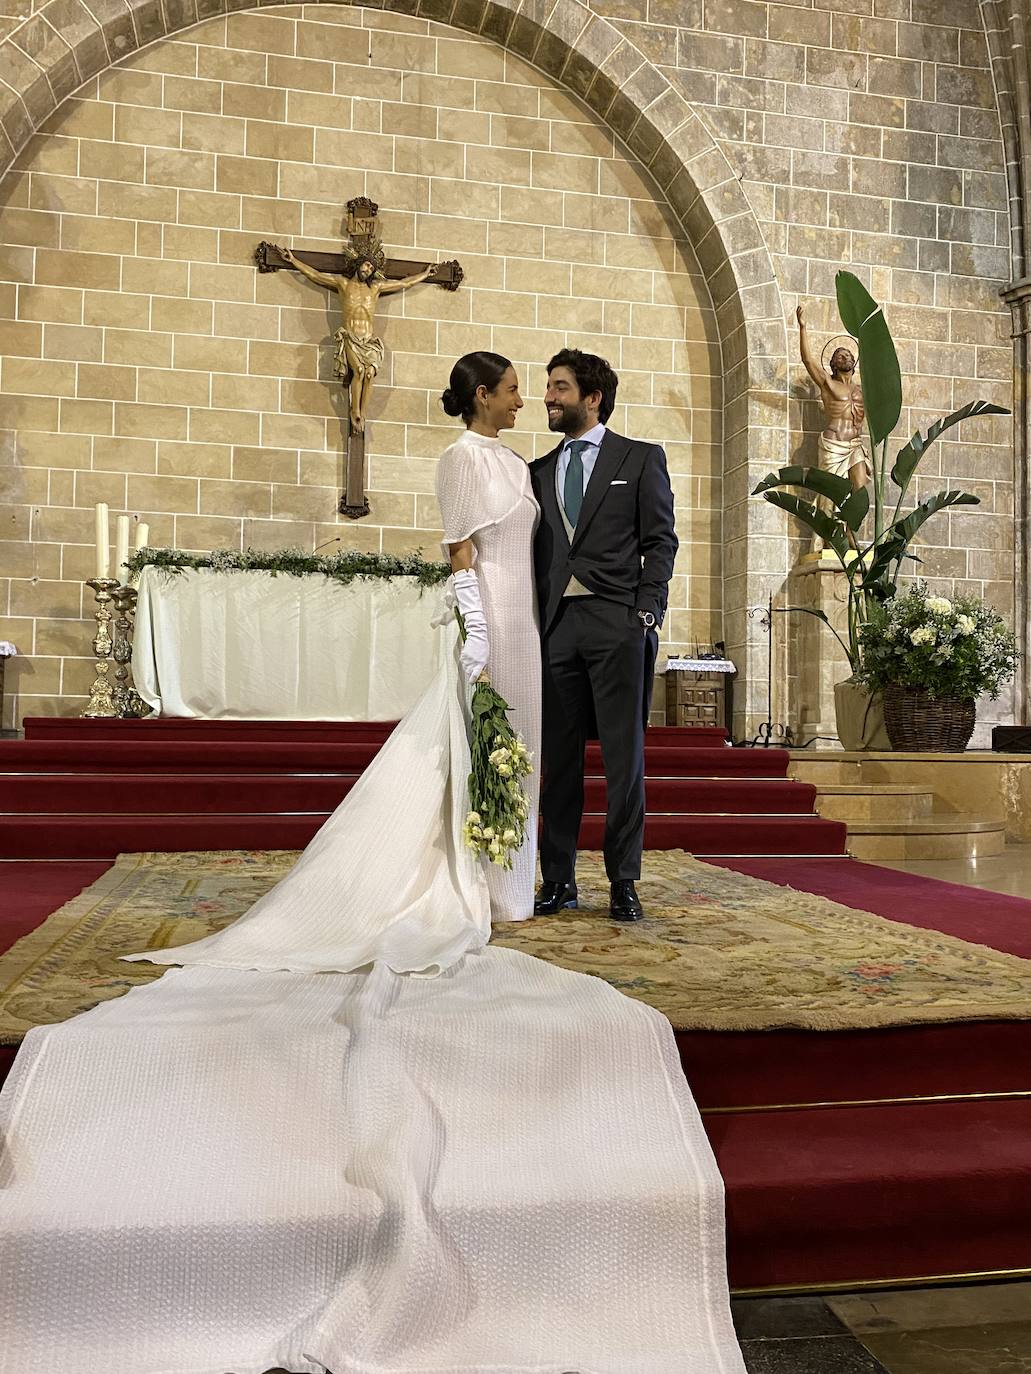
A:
[{"left": 0, "top": 434, "right": 744, "bottom": 1374}]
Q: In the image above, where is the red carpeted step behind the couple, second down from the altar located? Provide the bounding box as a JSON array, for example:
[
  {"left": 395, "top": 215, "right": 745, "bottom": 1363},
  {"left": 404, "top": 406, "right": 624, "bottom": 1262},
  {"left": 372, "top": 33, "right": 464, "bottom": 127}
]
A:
[{"left": 0, "top": 739, "right": 789, "bottom": 786}]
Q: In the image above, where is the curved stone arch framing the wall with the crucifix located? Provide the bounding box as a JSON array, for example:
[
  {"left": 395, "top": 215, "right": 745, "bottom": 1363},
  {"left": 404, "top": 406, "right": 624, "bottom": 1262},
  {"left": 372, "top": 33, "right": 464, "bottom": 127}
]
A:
[{"left": 0, "top": 0, "right": 788, "bottom": 732}]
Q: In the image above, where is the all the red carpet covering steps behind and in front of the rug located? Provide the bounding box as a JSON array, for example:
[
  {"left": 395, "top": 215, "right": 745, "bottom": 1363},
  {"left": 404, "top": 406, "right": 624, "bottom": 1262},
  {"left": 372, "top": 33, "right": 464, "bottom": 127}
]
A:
[{"left": 0, "top": 720, "right": 1031, "bottom": 1289}]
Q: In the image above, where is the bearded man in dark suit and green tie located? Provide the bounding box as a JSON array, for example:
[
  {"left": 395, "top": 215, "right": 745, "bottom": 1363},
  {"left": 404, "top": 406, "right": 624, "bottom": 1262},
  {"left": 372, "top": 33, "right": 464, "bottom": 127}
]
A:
[{"left": 529, "top": 349, "right": 678, "bottom": 921}]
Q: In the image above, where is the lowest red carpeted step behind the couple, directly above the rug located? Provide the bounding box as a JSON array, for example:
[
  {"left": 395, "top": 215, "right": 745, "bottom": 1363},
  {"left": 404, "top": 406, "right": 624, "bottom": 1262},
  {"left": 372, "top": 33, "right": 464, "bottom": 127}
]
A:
[{"left": 0, "top": 812, "right": 845, "bottom": 859}]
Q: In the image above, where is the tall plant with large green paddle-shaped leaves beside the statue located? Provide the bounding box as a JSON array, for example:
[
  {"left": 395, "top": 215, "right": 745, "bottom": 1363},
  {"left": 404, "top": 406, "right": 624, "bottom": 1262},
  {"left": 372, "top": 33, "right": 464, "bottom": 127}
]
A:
[{"left": 752, "top": 271, "right": 1009, "bottom": 675}]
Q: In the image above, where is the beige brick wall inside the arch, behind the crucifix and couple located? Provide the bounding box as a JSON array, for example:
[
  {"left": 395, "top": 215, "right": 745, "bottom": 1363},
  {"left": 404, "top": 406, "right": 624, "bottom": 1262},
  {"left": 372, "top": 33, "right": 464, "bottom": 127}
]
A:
[{"left": 0, "top": 5, "right": 722, "bottom": 724}]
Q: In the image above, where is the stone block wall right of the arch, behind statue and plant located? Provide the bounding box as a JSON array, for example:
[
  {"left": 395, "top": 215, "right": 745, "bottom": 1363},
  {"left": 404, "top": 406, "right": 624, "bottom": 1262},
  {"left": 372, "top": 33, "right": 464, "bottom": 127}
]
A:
[{"left": 602, "top": 0, "right": 1013, "bottom": 692}]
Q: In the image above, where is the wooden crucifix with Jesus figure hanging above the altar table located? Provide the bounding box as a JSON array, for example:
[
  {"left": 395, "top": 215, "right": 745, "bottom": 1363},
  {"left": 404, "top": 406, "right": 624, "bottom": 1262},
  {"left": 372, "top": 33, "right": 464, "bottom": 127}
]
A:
[{"left": 254, "top": 195, "right": 463, "bottom": 519}]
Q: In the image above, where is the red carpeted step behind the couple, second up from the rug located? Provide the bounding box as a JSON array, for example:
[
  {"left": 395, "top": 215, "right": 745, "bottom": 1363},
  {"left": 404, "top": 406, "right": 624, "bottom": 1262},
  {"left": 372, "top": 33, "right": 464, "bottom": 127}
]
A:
[{"left": 0, "top": 772, "right": 817, "bottom": 815}]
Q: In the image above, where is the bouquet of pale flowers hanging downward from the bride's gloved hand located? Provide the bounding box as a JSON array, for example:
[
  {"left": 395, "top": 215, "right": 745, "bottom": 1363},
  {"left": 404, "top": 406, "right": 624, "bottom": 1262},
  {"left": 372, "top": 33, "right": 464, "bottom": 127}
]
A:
[{"left": 456, "top": 611, "right": 533, "bottom": 868}]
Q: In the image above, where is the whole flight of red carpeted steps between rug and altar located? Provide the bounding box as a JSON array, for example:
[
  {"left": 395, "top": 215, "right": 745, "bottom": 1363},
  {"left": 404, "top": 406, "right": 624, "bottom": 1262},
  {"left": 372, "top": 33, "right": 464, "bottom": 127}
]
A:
[{"left": 0, "top": 719, "right": 845, "bottom": 859}]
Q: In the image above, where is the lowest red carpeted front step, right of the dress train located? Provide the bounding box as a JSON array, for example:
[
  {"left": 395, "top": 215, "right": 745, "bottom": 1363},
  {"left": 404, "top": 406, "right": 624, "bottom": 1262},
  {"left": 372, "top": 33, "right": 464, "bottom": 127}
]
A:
[{"left": 705, "top": 1099, "right": 1031, "bottom": 1289}]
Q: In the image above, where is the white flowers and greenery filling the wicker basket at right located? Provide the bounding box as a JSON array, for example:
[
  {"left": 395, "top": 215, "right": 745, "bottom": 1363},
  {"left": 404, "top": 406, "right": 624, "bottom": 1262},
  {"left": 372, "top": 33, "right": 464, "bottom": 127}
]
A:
[{"left": 856, "top": 583, "right": 1017, "bottom": 701}]
